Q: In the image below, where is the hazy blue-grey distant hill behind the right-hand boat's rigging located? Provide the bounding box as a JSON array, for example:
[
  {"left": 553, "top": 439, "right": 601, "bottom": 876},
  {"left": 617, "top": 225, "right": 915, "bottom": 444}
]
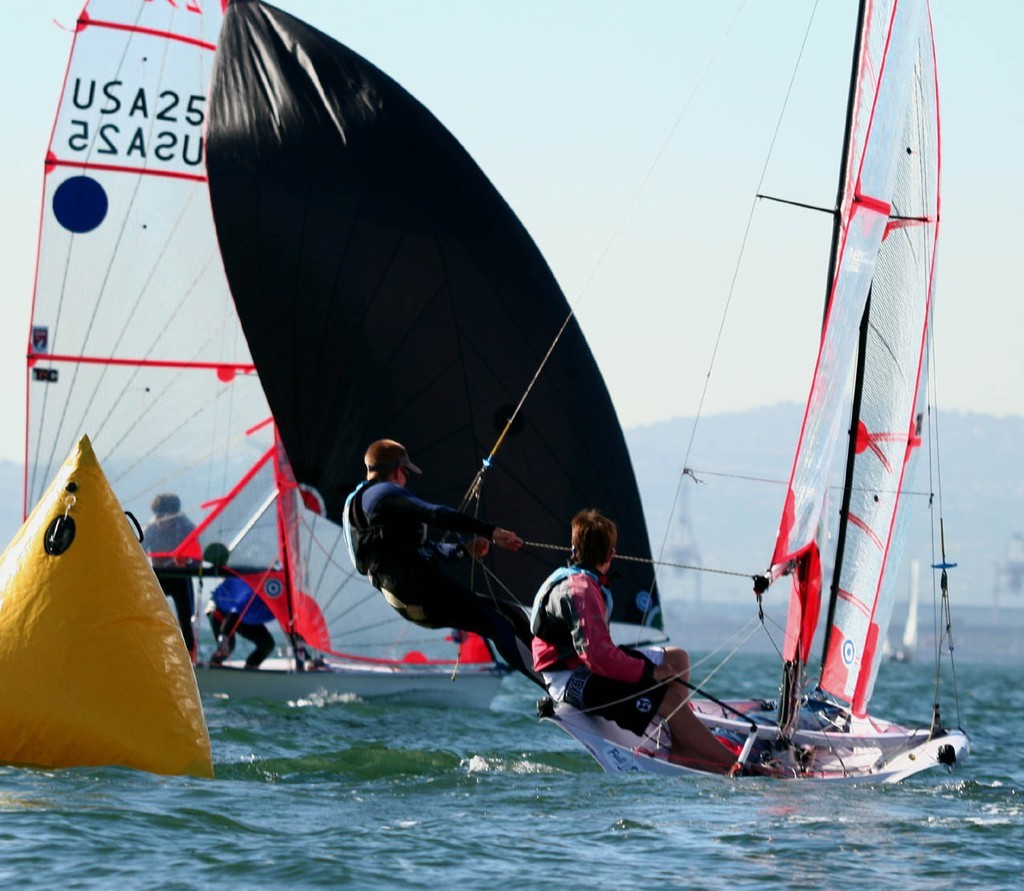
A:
[{"left": 626, "top": 404, "right": 1024, "bottom": 610}]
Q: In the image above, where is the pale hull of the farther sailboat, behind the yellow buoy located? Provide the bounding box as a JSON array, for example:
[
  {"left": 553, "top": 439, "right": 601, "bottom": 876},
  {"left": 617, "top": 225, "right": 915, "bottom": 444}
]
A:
[{"left": 196, "top": 659, "right": 508, "bottom": 709}]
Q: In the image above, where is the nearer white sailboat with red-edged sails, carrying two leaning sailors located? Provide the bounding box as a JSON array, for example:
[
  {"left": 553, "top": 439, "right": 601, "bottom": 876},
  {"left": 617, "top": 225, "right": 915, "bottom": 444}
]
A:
[{"left": 546, "top": 0, "right": 969, "bottom": 782}]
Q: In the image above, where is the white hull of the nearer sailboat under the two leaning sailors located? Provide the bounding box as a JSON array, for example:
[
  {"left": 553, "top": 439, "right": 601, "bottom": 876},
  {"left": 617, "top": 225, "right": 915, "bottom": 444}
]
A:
[{"left": 545, "top": 701, "right": 970, "bottom": 783}]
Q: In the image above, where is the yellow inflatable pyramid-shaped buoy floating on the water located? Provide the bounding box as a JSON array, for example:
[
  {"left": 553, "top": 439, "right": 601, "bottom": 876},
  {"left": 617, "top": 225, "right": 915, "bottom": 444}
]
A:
[{"left": 0, "top": 436, "right": 213, "bottom": 776}]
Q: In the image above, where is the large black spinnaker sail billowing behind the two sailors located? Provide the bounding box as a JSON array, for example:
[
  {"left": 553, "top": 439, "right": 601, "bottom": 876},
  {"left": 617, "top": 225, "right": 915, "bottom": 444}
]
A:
[{"left": 207, "top": 0, "right": 662, "bottom": 627}]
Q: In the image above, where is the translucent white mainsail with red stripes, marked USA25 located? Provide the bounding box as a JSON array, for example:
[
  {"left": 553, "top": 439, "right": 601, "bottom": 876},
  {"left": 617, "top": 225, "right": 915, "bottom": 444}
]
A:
[{"left": 26, "top": 0, "right": 270, "bottom": 522}]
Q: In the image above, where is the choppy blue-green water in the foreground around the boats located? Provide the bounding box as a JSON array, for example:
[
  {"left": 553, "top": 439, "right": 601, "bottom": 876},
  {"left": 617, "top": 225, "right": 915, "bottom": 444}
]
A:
[{"left": 0, "top": 656, "right": 1024, "bottom": 891}]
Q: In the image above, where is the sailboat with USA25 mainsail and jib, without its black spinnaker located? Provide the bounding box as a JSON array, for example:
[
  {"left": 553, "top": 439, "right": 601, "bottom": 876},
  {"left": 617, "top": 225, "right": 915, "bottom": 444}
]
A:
[{"left": 25, "top": 0, "right": 506, "bottom": 708}]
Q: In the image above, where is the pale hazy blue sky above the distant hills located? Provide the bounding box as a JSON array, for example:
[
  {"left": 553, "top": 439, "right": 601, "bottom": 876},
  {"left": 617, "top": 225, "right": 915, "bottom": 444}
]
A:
[{"left": 0, "top": 0, "right": 1024, "bottom": 461}]
